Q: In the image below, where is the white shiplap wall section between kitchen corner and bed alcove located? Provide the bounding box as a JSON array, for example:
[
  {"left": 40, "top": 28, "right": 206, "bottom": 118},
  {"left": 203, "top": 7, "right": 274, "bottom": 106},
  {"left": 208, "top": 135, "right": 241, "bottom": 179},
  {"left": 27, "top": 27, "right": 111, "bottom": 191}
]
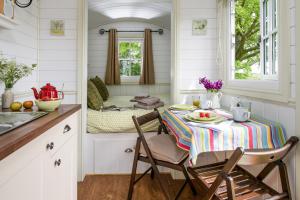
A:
[{"left": 39, "top": 0, "right": 78, "bottom": 103}]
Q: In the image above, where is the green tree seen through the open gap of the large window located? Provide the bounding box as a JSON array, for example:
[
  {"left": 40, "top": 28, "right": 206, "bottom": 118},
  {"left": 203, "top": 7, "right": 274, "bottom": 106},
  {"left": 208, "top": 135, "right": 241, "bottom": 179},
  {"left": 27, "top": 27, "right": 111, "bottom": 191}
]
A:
[{"left": 235, "top": 0, "right": 260, "bottom": 79}]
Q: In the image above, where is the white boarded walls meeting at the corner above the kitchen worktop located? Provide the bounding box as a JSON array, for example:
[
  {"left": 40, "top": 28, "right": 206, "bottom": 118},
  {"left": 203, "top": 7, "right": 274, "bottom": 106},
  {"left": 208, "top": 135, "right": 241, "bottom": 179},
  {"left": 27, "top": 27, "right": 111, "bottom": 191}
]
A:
[{"left": 0, "top": 0, "right": 78, "bottom": 103}]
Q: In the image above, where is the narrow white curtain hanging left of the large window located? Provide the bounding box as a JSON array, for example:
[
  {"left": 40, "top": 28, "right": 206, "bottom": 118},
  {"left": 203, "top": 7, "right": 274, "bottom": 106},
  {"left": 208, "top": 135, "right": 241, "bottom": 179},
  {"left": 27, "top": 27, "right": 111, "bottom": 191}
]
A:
[{"left": 217, "top": 0, "right": 231, "bottom": 79}]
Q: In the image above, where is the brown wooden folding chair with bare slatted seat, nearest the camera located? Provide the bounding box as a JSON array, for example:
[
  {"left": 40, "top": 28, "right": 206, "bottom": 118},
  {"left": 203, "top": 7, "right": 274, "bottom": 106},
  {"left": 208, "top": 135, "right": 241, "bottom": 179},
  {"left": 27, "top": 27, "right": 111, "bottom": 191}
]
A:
[{"left": 188, "top": 137, "right": 298, "bottom": 200}]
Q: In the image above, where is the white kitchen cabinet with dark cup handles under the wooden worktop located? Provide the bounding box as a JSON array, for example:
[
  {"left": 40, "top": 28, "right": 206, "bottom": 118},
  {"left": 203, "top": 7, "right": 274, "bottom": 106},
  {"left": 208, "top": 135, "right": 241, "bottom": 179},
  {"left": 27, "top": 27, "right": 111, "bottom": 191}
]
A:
[{"left": 0, "top": 113, "right": 78, "bottom": 200}]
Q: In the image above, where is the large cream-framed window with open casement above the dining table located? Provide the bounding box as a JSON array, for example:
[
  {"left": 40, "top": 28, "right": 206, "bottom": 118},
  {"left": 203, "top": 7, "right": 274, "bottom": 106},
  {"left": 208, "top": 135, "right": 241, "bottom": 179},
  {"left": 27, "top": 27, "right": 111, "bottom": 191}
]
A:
[{"left": 225, "top": 0, "right": 291, "bottom": 103}]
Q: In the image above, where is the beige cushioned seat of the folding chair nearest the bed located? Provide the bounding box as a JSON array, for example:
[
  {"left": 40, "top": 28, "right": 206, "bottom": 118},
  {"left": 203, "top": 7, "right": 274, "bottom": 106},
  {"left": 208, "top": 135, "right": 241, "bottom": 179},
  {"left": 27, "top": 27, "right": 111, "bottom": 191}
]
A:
[{"left": 140, "top": 134, "right": 188, "bottom": 164}]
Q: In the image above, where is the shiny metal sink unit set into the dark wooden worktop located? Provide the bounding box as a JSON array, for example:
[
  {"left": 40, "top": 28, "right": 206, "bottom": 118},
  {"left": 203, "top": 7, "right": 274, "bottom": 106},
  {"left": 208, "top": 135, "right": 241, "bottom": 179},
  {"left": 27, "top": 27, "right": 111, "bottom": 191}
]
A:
[{"left": 0, "top": 112, "right": 48, "bottom": 135}]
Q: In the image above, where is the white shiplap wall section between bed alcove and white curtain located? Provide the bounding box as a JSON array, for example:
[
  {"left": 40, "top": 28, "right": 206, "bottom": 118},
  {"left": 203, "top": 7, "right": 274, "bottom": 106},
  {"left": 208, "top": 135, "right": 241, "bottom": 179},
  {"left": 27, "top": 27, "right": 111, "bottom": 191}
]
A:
[{"left": 176, "top": 0, "right": 219, "bottom": 90}]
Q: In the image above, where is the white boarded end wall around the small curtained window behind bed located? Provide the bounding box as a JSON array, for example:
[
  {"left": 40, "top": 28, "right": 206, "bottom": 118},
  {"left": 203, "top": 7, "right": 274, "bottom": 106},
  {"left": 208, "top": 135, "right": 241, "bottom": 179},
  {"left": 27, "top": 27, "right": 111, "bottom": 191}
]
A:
[{"left": 88, "top": 21, "right": 171, "bottom": 96}]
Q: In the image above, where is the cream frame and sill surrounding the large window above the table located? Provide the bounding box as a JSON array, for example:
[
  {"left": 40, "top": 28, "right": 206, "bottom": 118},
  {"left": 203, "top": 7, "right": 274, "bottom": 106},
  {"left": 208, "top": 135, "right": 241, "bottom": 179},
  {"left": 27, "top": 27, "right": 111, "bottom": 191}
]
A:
[{"left": 221, "top": 0, "right": 291, "bottom": 102}]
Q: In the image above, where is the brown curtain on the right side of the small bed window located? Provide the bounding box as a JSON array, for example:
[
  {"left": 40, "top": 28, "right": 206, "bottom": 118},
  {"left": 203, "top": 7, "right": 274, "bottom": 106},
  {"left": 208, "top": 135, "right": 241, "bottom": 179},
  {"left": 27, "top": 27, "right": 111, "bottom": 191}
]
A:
[{"left": 140, "top": 29, "right": 155, "bottom": 85}]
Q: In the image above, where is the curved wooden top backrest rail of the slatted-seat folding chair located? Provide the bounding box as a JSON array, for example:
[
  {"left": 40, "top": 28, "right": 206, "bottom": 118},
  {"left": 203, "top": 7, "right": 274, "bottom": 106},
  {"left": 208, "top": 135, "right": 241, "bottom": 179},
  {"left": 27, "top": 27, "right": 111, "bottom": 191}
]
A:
[{"left": 238, "top": 136, "right": 299, "bottom": 165}]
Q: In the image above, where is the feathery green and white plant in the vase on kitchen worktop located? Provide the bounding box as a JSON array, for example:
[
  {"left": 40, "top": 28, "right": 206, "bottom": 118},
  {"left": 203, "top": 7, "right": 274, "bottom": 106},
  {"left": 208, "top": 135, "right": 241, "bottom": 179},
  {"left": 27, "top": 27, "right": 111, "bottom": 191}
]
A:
[{"left": 0, "top": 56, "right": 36, "bottom": 89}]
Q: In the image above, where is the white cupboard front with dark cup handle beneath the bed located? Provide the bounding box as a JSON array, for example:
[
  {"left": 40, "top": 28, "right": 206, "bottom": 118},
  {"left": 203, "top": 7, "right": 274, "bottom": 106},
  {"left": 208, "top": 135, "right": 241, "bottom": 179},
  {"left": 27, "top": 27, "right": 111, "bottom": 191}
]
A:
[{"left": 84, "top": 133, "right": 157, "bottom": 174}]
